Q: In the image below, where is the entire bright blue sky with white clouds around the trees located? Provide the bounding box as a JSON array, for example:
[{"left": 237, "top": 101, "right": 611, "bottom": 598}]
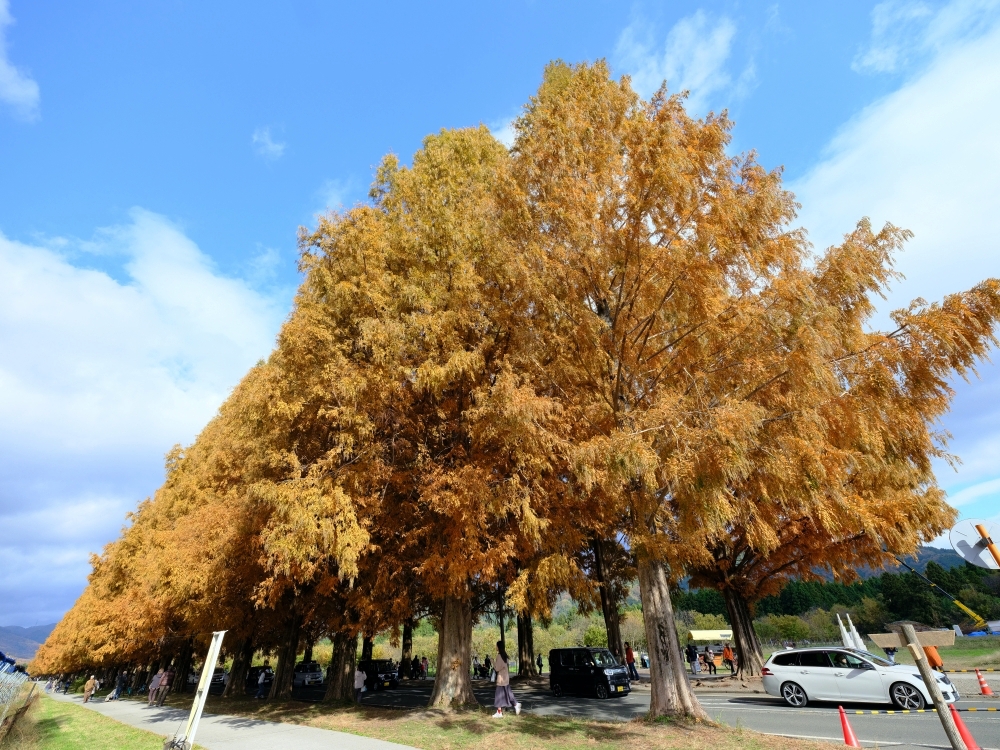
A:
[{"left": 0, "top": 0, "right": 1000, "bottom": 625}]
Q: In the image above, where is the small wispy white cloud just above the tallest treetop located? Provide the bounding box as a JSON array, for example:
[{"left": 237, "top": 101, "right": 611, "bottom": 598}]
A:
[{"left": 615, "top": 10, "right": 753, "bottom": 113}]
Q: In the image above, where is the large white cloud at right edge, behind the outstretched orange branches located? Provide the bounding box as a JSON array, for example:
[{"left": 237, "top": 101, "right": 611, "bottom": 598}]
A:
[{"left": 791, "top": 2, "right": 1000, "bottom": 536}]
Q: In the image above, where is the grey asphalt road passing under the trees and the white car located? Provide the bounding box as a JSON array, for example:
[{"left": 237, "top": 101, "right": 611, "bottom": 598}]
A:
[{"left": 354, "top": 681, "right": 1000, "bottom": 750}]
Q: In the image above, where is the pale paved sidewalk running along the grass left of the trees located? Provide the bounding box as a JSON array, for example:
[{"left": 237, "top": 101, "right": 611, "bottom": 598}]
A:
[{"left": 44, "top": 693, "right": 412, "bottom": 750}]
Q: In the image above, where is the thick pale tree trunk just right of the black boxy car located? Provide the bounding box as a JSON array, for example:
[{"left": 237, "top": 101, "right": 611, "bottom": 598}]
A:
[{"left": 638, "top": 553, "right": 708, "bottom": 721}]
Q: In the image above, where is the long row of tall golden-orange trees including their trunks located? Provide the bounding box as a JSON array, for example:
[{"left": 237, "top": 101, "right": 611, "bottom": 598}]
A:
[{"left": 34, "top": 63, "right": 1000, "bottom": 717}]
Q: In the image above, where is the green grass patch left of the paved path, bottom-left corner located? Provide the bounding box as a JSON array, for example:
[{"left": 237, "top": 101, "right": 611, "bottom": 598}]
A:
[{"left": 0, "top": 696, "right": 163, "bottom": 750}]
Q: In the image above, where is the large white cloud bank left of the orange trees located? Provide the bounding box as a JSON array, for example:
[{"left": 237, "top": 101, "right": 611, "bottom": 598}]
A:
[{"left": 0, "top": 210, "right": 284, "bottom": 624}]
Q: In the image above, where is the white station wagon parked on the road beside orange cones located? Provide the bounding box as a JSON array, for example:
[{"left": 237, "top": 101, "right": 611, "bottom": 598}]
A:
[{"left": 761, "top": 648, "right": 959, "bottom": 710}]
